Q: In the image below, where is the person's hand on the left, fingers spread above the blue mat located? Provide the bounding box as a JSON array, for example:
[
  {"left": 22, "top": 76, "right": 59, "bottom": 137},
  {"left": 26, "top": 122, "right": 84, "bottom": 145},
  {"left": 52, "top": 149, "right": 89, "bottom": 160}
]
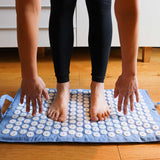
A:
[{"left": 20, "top": 76, "right": 49, "bottom": 116}]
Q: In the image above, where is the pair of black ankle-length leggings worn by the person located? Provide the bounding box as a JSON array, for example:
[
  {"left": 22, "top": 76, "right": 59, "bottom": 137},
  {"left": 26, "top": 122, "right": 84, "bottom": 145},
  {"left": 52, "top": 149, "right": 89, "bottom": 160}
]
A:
[{"left": 49, "top": 0, "right": 112, "bottom": 83}]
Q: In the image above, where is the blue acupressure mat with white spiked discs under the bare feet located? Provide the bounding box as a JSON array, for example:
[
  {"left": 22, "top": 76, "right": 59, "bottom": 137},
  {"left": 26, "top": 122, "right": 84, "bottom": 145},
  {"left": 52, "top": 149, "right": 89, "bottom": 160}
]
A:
[{"left": 0, "top": 89, "right": 160, "bottom": 143}]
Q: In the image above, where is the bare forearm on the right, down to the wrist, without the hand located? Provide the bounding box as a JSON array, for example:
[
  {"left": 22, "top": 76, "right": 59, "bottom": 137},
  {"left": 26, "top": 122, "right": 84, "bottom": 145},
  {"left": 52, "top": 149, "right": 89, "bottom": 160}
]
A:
[{"left": 115, "top": 0, "right": 139, "bottom": 76}]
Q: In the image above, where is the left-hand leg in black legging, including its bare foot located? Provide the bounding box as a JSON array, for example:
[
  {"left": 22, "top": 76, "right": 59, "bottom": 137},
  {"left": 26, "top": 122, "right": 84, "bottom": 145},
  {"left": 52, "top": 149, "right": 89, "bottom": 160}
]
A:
[{"left": 48, "top": 0, "right": 76, "bottom": 121}]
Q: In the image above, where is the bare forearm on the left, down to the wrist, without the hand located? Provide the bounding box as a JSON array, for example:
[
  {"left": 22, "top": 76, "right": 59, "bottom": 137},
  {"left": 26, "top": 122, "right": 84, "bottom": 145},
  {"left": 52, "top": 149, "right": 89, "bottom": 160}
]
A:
[{"left": 16, "top": 0, "right": 40, "bottom": 78}]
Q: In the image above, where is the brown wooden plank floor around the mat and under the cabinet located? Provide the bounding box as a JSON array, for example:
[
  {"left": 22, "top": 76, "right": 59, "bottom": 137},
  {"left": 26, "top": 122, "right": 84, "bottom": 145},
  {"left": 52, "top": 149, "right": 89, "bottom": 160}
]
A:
[{"left": 0, "top": 48, "right": 160, "bottom": 160}]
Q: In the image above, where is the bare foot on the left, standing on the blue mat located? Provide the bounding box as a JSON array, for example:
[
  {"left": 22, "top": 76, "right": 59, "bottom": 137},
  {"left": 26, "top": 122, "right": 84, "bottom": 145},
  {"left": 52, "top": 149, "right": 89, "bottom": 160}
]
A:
[{"left": 47, "top": 82, "right": 70, "bottom": 122}]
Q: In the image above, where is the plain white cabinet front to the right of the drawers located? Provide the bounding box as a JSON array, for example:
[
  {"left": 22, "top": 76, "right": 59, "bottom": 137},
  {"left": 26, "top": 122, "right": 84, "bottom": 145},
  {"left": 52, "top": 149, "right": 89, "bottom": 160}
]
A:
[{"left": 77, "top": 0, "right": 160, "bottom": 47}]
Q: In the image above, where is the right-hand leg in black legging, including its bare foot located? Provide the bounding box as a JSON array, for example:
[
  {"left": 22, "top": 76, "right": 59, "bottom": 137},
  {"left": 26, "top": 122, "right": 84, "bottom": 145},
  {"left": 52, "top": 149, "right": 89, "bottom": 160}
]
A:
[{"left": 86, "top": 0, "right": 112, "bottom": 121}]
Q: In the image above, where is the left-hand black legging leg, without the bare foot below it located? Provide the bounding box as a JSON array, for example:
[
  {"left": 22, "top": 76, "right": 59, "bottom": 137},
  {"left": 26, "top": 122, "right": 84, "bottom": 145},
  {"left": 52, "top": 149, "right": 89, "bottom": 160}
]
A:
[{"left": 49, "top": 0, "right": 76, "bottom": 83}]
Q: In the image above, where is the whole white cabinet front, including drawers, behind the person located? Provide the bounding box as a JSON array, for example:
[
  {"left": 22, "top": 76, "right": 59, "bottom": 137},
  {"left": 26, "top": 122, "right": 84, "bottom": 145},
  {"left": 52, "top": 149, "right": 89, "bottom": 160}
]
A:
[{"left": 0, "top": 0, "right": 160, "bottom": 47}]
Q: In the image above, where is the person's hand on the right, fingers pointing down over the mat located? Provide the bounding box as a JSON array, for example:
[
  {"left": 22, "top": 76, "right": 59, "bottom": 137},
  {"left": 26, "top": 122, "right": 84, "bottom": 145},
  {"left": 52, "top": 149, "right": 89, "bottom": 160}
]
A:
[{"left": 114, "top": 75, "right": 139, "bottom": 115}]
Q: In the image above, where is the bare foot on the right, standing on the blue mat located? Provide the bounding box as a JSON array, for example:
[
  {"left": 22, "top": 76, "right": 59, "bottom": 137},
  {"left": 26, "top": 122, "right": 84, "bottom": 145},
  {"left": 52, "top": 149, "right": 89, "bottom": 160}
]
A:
[{"left": 90, "top": 81, "right": 110, "bottom": 121}]
